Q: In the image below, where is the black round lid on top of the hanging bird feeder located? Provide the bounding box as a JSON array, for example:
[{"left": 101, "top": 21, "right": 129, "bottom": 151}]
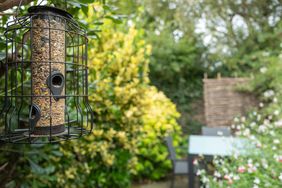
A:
[{"left": 27, "top": 6, "right": 72, "bottom": 18}]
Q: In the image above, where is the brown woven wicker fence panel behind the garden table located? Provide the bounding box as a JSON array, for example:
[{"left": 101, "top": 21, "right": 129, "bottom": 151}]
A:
[{"left": 203, "top": 78, "right": 257, "bottom": 127}]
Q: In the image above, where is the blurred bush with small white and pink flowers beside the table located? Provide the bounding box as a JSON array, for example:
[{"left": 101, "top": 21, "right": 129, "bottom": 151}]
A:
[{"left": 197, "top": 50, "right": 282, "bottom": 188}]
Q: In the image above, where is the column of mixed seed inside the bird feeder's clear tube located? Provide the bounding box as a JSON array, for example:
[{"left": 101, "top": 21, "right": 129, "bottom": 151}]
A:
[{"left": 29, "top": 6, "right": 65, "bottom": 135}]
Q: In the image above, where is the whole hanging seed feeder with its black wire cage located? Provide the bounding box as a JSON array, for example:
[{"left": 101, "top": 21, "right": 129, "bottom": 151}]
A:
[{"left": 0, "top": 6, "right": 93, "bottom": 143}]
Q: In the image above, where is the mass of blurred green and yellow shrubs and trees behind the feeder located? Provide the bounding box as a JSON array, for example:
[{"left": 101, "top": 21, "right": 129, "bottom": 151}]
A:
[{"left": 0, "top": 0, "right": 282, "bottom": 187}]
